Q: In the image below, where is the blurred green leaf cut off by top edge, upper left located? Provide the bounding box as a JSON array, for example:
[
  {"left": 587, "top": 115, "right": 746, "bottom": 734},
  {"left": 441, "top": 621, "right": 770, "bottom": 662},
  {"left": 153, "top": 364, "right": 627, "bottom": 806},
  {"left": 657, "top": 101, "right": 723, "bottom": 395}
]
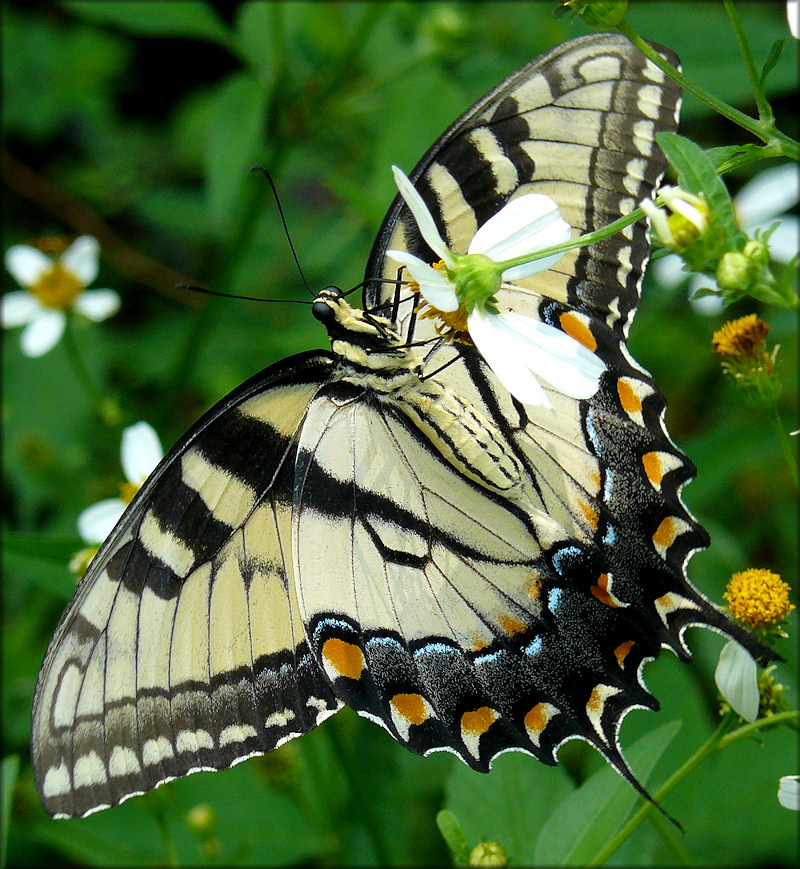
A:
[{"left": 63, "top": 0, "right": 231, "bottom": 47}]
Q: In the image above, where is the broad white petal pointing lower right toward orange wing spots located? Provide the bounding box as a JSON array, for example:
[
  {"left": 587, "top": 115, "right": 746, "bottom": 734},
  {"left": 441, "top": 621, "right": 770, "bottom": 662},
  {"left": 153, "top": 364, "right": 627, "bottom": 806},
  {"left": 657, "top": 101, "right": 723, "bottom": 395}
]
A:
[{"left": 488, "top": 311, "right": 606, "bottom": 398}]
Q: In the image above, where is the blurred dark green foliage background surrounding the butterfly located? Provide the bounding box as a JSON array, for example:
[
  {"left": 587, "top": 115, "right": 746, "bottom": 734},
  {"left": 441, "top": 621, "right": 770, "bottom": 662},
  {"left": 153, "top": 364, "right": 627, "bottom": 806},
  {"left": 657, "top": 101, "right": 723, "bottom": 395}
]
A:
[{"left": 2, "top": 2, "right": 798, "bottom": 865}]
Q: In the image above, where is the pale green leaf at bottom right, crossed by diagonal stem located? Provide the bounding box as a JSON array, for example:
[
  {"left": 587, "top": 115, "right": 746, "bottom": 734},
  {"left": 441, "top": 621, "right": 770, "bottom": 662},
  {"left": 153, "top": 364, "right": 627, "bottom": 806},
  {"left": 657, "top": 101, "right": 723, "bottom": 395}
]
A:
[{"left": 533, "top": 721, "right": 681, "bottom": 866}]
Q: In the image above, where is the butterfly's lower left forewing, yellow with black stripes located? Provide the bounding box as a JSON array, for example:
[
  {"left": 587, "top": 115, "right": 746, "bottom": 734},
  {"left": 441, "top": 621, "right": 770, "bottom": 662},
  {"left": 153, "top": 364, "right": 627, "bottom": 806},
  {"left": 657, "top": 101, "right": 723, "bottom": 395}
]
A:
[{"left": 31, "top": 353, "right": 341, "bottom": 817}]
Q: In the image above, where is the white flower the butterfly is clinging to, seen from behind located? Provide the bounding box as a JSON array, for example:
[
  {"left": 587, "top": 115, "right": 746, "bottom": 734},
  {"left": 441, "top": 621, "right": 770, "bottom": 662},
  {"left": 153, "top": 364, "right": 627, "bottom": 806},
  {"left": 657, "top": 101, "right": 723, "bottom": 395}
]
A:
[{"left": 386, "top": 166, "right": 605, "bottom": 407}]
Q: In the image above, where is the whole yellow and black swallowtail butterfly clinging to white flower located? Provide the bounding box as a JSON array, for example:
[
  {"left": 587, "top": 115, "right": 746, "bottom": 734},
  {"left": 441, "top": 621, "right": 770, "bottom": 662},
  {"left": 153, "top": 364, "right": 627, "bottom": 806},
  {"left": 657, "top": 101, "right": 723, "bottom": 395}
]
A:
[{"left": 32, "top": 35, "right": 767, "bottom": 817}]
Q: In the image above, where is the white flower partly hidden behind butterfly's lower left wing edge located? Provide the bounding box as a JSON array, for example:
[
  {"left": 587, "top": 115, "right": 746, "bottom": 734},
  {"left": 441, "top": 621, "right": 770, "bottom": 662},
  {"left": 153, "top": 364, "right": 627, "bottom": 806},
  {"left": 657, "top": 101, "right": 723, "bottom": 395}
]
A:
[{"left": 78, "top": 422, "right": 164, "bottom": 543}]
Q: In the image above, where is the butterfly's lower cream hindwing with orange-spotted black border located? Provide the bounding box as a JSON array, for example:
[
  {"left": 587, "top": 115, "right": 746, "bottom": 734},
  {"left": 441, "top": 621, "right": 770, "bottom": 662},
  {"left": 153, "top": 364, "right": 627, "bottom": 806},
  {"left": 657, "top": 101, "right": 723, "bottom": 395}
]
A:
[{"left": 293, "top": 383, "right": 668, "bottom": 774}]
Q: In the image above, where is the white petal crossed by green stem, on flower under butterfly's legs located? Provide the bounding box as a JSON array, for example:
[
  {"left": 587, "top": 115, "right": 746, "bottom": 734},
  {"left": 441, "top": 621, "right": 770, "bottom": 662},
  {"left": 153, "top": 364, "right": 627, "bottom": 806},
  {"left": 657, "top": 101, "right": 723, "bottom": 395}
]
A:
[{"left": 468, "top": 193, "right": 572, "bottom": 280}]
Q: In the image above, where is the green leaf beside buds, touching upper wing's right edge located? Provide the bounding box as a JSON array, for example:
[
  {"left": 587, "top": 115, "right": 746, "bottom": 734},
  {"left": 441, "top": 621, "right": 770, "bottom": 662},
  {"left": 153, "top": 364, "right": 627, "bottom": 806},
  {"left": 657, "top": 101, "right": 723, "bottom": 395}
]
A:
[{"left": 656, "top": 133, "right": 747, "bottom": 252}]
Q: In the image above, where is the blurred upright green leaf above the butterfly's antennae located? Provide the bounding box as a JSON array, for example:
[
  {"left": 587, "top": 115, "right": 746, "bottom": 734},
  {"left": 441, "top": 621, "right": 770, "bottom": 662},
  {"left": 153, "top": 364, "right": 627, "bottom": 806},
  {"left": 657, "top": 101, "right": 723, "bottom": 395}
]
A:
[{"left": 206, "top": 72, "right": 268, "bottom": 226}]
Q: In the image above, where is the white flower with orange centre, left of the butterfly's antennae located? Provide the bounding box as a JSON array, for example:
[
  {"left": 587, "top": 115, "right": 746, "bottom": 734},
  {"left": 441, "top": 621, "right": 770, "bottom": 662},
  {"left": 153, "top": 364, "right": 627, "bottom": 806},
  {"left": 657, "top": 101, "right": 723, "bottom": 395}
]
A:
[{"left": 0, "top": 235, "right": 120, "bottom": 356}]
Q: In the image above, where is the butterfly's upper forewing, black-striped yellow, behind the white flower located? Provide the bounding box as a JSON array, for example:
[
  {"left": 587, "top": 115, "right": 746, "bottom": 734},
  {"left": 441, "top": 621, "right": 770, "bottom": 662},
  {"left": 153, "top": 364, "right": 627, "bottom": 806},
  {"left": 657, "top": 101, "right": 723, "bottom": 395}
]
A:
[{"left": 365, "top": 34, "right": 680, "bottom": 337}]
